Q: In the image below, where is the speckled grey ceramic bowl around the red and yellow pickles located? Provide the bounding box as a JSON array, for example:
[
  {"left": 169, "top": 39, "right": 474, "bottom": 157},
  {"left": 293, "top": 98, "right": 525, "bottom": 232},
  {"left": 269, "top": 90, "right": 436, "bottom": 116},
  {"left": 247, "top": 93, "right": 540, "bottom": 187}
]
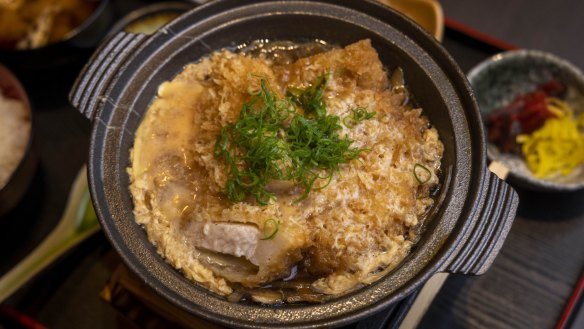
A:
[{"left": 468, "top": 50, "right": 584, "bottom": 192}]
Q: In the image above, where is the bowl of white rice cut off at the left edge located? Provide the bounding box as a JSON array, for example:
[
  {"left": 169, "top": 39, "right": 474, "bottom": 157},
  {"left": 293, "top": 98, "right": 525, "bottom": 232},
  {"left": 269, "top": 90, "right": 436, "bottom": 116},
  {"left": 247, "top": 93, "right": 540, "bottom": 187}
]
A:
[{"left": 0, "top": 64, "right": 36, "bottom": 216}]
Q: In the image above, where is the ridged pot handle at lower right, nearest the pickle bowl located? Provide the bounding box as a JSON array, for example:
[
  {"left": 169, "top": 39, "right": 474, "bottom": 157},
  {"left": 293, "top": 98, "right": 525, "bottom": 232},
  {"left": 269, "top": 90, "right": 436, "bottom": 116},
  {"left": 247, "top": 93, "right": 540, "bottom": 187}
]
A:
[{"left": 445, "top": 171, "right": 519, "bottom": 275}]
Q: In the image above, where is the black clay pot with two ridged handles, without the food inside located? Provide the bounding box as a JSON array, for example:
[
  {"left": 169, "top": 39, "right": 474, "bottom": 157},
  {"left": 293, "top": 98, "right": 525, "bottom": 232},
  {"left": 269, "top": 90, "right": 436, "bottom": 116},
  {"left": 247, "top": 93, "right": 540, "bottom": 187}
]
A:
[{"left": 71, "top": 0, "right": 518, "bottom": 328}]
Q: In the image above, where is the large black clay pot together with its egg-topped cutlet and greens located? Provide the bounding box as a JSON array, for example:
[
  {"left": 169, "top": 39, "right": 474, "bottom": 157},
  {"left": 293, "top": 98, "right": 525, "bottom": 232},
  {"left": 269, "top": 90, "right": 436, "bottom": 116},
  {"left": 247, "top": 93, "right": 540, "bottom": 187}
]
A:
[{"left": 70, "top": 0, "right": 518, "bottom": 328}]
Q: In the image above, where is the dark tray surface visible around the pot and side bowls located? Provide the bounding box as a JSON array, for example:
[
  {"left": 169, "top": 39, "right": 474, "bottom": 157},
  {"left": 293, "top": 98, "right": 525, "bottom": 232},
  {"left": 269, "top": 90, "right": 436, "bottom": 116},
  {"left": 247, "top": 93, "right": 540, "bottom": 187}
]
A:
[{"left": 0, "top": 1, "right": 584, "bottom": 328}]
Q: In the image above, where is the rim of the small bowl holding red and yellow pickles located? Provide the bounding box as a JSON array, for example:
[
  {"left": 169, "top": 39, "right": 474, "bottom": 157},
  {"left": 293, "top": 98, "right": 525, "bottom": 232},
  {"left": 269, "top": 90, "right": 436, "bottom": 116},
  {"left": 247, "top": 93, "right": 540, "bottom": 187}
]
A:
[{"left": 467, "top": 49, "right": 584, "bottom": 193}]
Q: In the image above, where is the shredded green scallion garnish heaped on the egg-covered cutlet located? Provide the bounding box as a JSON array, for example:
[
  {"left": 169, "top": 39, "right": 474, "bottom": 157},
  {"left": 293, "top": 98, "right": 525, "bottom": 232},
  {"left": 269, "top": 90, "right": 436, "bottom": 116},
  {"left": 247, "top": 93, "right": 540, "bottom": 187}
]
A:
[{"left": 214, "top": 75, "right": 375, "bottom": 205}]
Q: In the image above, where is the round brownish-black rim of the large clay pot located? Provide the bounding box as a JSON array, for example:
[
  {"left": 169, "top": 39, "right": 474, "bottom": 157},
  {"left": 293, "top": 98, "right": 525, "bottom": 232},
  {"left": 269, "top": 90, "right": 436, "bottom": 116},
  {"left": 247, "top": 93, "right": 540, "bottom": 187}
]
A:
[{"left": 75, "top": 0, "right": 487, "bottom": 328}]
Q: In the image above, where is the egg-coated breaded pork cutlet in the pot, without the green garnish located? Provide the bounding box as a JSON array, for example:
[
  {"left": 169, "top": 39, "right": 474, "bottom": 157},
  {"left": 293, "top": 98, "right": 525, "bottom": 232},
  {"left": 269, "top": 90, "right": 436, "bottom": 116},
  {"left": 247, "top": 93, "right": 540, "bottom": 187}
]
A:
[{"left": 128, "top": 40, "right": 443, "bottom": 302}]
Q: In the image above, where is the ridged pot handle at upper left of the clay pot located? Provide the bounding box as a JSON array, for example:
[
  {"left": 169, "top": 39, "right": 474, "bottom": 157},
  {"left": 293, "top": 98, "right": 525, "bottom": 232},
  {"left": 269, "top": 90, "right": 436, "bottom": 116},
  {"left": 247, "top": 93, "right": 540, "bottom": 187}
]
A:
[{"left": 69, "top": 32, "right": 146, "bottom": 120}]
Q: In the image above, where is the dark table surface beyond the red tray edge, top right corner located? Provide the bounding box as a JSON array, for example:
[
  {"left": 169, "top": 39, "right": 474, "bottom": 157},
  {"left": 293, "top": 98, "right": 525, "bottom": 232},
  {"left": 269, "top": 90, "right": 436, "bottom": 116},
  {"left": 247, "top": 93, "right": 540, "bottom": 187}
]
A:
[{"left": 439, "top": 0, "right": 584, "bottom": 69}]
